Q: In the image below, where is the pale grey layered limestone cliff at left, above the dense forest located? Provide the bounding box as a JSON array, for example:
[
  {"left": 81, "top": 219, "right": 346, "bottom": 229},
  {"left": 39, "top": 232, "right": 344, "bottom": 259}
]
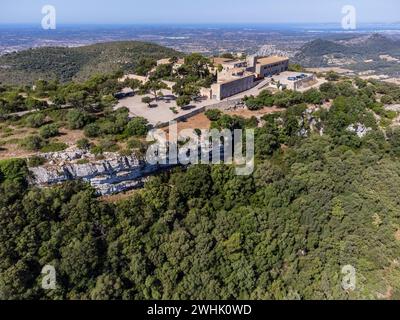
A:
[{"left": 29, "top": 149, "right": 172, "bottom": 195}]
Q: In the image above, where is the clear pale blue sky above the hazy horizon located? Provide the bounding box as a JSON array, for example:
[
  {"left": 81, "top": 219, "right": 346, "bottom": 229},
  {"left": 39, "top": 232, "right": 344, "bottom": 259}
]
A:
[{"left": 0, "top": 0, "right": 400, "bottom": 24}]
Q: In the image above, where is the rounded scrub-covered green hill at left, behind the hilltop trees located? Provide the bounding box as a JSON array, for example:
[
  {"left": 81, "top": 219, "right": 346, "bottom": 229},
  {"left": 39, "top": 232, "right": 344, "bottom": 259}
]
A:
[{"left": 0, "top": 41, "right": 182, "bottom": 84}]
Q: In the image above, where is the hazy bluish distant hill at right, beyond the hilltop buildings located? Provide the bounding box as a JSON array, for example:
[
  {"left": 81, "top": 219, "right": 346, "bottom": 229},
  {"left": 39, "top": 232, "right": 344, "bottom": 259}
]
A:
[{"left": 294, "top": 34, "right": 400, "bottom": 67}]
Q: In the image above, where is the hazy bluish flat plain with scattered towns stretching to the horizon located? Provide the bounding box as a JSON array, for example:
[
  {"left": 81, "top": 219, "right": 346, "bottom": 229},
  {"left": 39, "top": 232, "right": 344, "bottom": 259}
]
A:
[{"left": 0, "top": 24, "right": 400, "bottom": 57}]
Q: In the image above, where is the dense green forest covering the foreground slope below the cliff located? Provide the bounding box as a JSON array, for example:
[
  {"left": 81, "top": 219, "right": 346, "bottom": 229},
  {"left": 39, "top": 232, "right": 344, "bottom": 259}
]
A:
[{"left": 0, "top": 75, "right": 400, "bottom": 299}]
